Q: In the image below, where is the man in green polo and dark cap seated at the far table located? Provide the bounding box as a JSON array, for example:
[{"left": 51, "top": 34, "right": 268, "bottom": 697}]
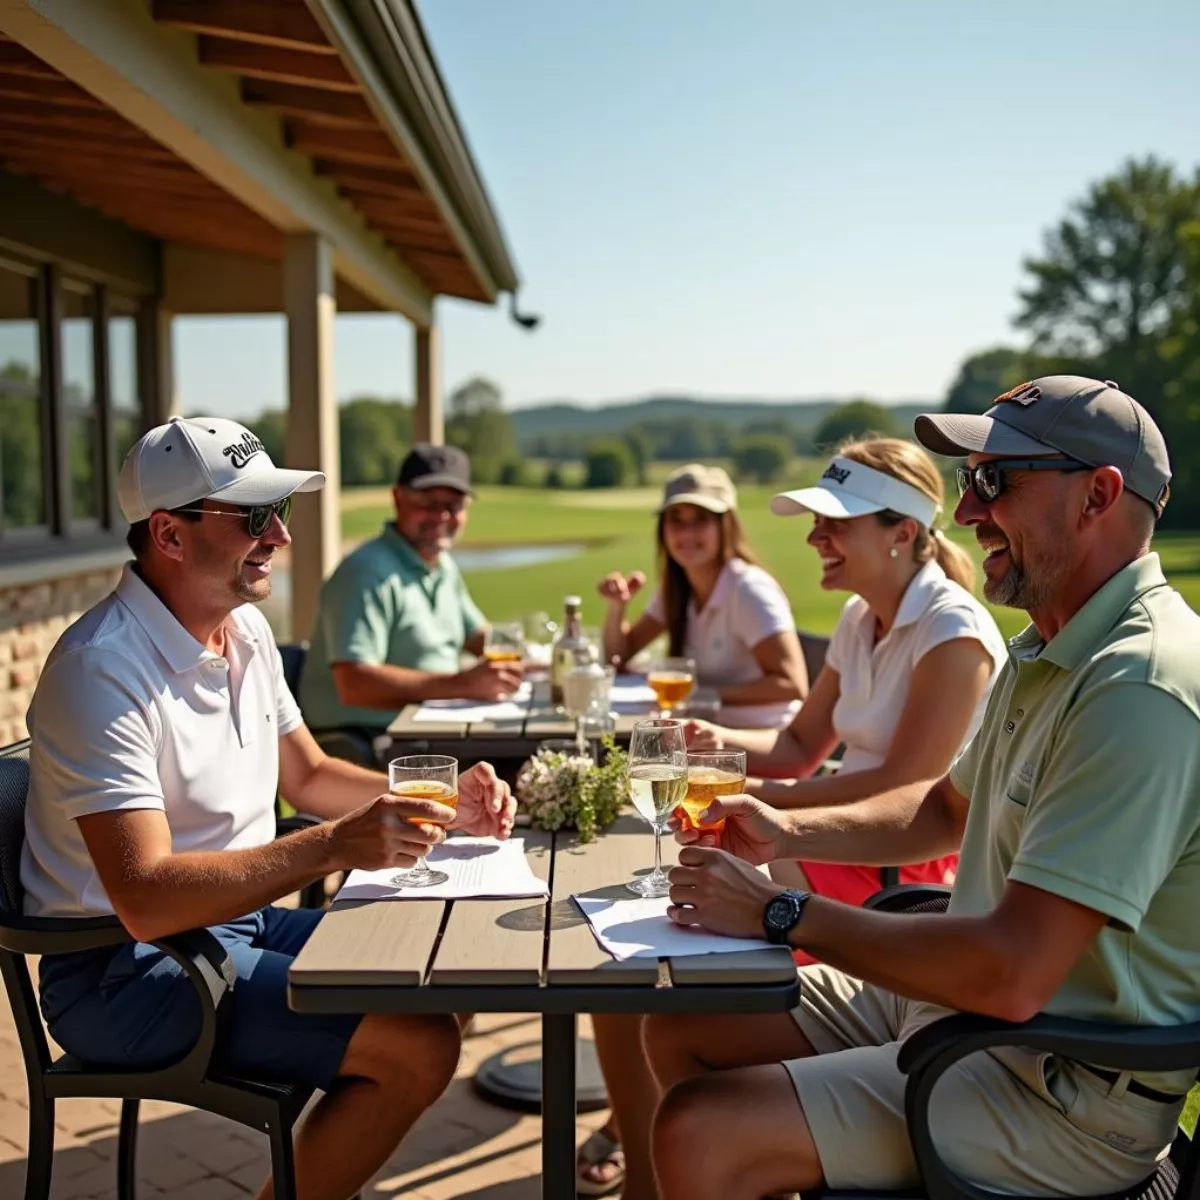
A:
[{"left": 299, "top": 444, "right": 521, "bottom": 739}]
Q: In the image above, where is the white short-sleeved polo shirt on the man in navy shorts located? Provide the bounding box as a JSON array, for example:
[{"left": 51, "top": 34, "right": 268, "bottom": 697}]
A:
[{"left": 20, "top": 563, "right": 301, "bottom": 917}]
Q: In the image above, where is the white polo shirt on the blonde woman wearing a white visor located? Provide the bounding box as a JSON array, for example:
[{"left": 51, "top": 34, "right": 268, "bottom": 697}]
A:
[{"left": 826, "top": 562, "right": 1008, "bottom": 774}]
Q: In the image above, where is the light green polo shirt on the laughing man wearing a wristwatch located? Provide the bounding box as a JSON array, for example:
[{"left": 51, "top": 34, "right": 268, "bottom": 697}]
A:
[{"left": 950, "top": 554, "right": 1200, "bottom": 1092}]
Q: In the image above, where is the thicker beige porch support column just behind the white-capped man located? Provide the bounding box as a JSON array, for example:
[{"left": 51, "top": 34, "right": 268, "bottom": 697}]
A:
[{"left": 283, "top": 233, "right": 341, "bottom": 641}]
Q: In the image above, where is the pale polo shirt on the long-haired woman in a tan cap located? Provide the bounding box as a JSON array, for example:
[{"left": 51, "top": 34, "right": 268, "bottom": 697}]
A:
[{"left": 646, "top": 558, "right": 800, "bottom": 728}]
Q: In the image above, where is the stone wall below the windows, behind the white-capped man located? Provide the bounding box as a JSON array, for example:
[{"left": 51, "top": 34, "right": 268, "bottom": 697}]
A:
[{"left": 0, "top": 568, "right": 121, "bottom": 746}]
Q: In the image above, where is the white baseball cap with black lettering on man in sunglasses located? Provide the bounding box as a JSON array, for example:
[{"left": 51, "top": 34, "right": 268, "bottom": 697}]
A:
[{"left": 116, "top": 416, "right": 325, "bottom": 524}]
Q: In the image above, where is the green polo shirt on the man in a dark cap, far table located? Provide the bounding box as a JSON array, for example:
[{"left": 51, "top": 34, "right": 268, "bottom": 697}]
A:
[{"left": 300, "top": 522, "right": 486, "bottom": 730}]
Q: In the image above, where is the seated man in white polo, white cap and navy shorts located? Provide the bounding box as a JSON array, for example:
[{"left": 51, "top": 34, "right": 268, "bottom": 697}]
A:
[{"left": 22, "top": 418, "right": 514, "bottom": 1200}]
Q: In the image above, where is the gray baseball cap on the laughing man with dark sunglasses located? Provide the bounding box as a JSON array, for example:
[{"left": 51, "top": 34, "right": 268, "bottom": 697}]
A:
[{"left": 914, "top": 376, "right": 1171, "bottom": 515}]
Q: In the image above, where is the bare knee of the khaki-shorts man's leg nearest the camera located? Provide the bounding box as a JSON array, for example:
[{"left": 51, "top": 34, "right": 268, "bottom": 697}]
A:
[{"left": 654, "top": 1063, "right": 822, "bottom": 1200}]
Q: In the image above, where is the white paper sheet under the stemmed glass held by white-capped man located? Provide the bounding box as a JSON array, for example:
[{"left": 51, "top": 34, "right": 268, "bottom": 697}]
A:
[{"left": 337, "top": 838, "right": 550, "bottom": 900}]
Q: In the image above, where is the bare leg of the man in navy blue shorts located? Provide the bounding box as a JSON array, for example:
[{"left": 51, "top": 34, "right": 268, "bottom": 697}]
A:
[{"left": 259, "top": 1013, "right": 460, "bottom": 1200}]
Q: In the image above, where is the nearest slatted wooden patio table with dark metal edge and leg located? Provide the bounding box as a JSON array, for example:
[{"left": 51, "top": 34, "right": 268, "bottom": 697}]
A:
[{"left": 288, "top": 814, "right": 799, "bottom": 1200}]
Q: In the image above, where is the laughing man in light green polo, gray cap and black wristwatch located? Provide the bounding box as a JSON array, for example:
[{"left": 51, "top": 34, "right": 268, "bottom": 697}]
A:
[{"left": 646, "top": 376, "right": 1200, "bottom": 1200}]
